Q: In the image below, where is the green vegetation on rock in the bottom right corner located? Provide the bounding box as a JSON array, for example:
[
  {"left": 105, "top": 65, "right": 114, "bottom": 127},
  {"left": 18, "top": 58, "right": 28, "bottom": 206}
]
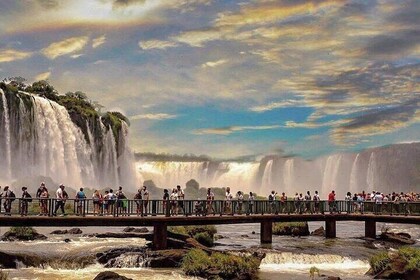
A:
[{"left": 369, "top": 247, "right": 420, "bottom": 274}]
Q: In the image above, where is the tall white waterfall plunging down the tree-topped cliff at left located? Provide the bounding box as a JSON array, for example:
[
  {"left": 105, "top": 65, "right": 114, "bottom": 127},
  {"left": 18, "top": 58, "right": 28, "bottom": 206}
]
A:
[{"left": 0, "top": 89, "right": 137, "bottom": 190}]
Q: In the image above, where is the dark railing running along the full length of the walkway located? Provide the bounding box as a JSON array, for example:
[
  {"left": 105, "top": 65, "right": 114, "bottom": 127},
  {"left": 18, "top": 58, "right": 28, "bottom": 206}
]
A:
[{"left": 0, "top": 198, "right": 420, "bottom": 217}]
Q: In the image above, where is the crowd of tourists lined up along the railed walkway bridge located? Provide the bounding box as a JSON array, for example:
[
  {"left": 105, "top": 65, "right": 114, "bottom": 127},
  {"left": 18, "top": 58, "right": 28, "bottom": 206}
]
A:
[{"left": 0, "top": 182, "right": 420, "bottom": 216}]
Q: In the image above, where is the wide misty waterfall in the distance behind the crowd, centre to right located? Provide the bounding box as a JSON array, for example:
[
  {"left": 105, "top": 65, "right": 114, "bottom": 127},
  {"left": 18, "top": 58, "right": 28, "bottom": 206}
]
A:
[{"left": 137, "top": 143, "right": 420, "bottom": 199}]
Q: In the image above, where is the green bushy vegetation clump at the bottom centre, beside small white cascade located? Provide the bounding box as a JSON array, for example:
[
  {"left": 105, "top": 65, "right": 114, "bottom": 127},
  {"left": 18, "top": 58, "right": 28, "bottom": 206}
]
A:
[{"left": 182, "top": 249, "right": 260, "bottom": 279}]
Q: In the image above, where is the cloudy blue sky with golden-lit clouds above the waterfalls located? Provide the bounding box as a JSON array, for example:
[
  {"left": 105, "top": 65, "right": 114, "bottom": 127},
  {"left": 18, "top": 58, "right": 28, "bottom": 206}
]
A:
[{"left": 0, "top": 0, "right": 420, "bottom": 158}]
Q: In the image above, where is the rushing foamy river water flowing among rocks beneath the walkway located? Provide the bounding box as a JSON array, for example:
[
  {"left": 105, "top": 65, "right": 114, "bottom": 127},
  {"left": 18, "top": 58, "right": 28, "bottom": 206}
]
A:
[{"left": 0, "top": 222, "right": 420, "bottom": 280}]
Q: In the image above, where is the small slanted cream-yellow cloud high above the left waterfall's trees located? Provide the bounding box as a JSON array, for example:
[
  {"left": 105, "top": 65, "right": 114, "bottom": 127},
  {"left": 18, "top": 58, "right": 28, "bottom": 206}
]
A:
[{"left": 41, "top": 36, "right": 89, "bottom": 59}]
